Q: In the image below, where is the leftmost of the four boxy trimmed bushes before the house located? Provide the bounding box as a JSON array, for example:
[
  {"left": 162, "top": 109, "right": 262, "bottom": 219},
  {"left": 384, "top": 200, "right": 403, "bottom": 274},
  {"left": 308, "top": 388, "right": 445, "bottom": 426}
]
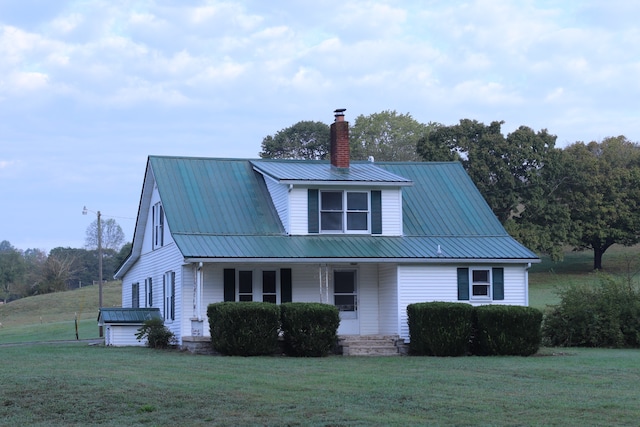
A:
[{"left": 207, "top": 302, "right": 280, "bottom": 356}]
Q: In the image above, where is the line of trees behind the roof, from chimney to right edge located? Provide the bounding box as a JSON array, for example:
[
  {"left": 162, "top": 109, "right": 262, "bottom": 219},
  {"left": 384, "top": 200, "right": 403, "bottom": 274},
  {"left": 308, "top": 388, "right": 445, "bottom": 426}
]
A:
[{"left": 259, "top": 111, "right": 640, "bottom": 270}]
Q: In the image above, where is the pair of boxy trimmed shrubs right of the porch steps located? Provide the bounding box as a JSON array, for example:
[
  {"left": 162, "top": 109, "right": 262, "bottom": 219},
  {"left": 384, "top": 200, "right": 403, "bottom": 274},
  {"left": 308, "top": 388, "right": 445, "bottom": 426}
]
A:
[{"left": 407, "top": 302, "right": 542, "bottom": 356}]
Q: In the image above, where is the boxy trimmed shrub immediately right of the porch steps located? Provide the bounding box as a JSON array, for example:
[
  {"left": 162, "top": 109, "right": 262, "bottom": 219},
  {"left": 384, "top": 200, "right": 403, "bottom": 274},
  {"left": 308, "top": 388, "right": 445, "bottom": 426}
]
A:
[{"left": 407, "top": 302, "right": 473, "bottom": 356}]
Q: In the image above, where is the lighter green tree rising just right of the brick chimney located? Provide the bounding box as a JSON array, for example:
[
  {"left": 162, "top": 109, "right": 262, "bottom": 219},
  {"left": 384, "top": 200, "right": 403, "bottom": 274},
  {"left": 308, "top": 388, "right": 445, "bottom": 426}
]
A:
[{"left": 349, "top": 110, "right": 429, "bottom": 162}]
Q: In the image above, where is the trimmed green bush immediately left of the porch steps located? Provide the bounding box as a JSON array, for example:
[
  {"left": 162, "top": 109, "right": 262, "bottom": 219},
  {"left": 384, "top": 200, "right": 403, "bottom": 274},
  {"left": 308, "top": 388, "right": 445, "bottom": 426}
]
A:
[{"left": 280, "top": 302, "right": 340, "bottom": 357}]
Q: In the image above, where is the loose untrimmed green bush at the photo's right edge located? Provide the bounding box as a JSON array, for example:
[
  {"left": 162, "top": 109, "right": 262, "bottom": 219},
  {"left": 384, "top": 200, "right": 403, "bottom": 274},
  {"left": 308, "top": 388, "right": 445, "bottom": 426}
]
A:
[{"left": 542, "top": 276, "right": 640, "bottom": 348}]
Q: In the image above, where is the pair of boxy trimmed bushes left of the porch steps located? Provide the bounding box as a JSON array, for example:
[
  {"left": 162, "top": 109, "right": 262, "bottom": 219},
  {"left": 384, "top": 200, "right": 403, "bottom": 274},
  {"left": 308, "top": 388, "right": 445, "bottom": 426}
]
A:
[{"left": 207, "top": 302, "right": 340, "bottom": 357}]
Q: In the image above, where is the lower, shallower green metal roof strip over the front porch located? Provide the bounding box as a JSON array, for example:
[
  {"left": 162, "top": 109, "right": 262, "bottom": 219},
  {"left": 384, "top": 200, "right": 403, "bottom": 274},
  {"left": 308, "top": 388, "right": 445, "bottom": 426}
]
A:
[{"left": 173, "top": 234, "right": 539, "bottom": 262}]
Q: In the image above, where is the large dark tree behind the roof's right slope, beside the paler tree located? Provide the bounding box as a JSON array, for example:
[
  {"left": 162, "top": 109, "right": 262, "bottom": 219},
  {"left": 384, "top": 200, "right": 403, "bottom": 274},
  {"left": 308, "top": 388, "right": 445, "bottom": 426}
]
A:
[{"left": 418, "top": 119, "right": 556, "bottom": 223}]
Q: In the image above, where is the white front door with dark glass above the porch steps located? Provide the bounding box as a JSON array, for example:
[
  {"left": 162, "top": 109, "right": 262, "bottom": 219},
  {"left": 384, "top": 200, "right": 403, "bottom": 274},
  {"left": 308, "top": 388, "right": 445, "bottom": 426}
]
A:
[{"left": 333, "top": 270, "right": 360, "bottom": 335}]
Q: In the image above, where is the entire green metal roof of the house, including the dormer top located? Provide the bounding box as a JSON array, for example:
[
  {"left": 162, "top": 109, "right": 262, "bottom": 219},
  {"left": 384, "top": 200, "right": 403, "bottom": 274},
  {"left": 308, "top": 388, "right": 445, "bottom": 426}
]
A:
[{"left": 144, "top": 156, "right": 537, "bottom": 262}]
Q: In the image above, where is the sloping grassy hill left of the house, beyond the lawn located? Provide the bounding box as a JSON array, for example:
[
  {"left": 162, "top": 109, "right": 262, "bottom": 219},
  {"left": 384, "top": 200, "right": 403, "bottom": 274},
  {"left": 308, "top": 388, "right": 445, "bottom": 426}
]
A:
[{"left": 0, "top": 282, "right": 122, "bottom": 344}]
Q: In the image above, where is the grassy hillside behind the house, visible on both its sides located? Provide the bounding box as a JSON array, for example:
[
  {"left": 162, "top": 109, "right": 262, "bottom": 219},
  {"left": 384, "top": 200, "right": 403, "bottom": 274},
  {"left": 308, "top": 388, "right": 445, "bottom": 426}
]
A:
[{"left": 0, "top": 245, "right": 640, "bottom": 344}]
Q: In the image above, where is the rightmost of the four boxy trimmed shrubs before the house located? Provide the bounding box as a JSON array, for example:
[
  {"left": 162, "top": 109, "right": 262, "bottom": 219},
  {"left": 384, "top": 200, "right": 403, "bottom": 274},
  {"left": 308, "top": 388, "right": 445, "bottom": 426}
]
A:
[{"left": 473, "top": 305, "right": 542, "bottom": 356}]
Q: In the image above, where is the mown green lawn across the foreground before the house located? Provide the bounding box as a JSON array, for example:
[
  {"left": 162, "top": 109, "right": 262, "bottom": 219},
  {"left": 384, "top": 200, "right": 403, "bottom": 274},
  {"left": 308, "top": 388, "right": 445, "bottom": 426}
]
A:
[{"left": 0, "top": 343, "right": 640, "bottom": 426}]
